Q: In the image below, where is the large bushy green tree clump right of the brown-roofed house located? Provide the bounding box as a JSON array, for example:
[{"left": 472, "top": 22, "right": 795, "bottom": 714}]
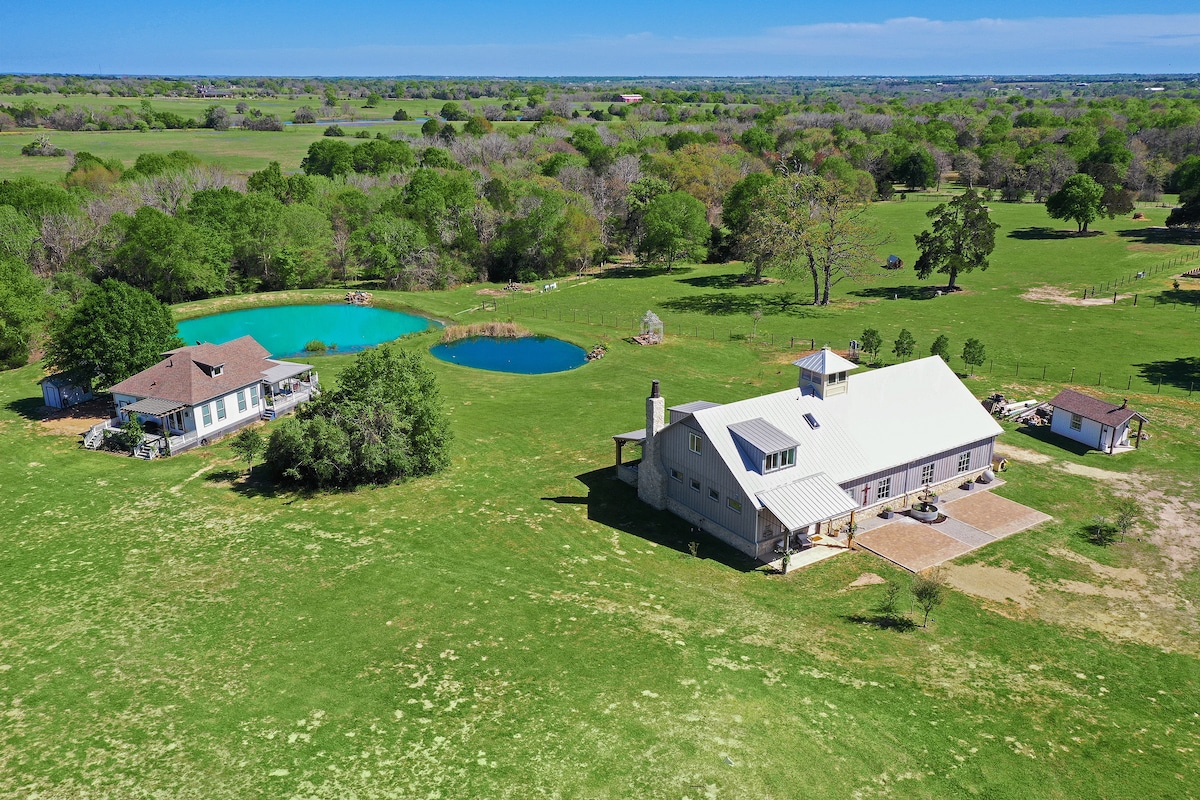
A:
[{"left": 266, "top": 347, "right": 451, "bottom": 488}]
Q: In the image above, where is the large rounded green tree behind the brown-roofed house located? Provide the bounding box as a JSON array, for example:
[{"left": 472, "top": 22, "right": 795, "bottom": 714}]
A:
[{"left": 46, "top": 278, "right": 184, "bottom": 389}]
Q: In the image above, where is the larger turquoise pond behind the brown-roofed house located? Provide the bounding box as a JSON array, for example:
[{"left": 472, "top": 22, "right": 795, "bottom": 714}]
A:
[{"left": 179, "top": 305, "right": 430, "bottom": 359}]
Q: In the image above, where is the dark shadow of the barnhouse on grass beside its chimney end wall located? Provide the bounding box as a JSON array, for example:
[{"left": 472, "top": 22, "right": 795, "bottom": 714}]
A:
[{"left": 561, "top": 467, "right": 762, "bottom": 572}]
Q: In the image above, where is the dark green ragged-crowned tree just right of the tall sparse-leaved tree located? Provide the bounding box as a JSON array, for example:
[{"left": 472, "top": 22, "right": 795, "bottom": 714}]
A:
[{"left": 916, "top": 190, "right": 1000, "bottom": 291}]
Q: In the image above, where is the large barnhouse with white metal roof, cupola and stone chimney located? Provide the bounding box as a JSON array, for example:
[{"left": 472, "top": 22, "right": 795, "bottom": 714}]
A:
[{"left": 613, "top": 348, "right": 1002, "bottom": 560}]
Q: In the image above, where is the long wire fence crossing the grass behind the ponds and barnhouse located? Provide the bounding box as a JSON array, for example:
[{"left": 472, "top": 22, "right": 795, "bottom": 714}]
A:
[{"left": 476, "top": 295, "right": 1200, "bottom": 398}]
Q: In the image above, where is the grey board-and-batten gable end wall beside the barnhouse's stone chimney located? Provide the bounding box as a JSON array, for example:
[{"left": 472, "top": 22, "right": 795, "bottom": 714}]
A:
[{"left": 659, "top": 420, "right": 758, "bottom": 542}]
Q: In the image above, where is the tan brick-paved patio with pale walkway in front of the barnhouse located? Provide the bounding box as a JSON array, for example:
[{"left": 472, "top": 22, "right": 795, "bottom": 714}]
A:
[{"left": 854, "top": 489, "right": 1050, "bottom": 572}]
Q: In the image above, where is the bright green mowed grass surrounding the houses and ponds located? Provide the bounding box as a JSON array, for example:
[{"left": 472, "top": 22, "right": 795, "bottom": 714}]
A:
[{"left": 0, "top": 201, "right": 1200, "bottom": 800}]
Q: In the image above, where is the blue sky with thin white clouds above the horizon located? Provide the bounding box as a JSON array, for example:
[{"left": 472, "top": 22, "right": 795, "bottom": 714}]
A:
[{"left": 0, "top": 0, "right": 1200, "bottom": 76}]
